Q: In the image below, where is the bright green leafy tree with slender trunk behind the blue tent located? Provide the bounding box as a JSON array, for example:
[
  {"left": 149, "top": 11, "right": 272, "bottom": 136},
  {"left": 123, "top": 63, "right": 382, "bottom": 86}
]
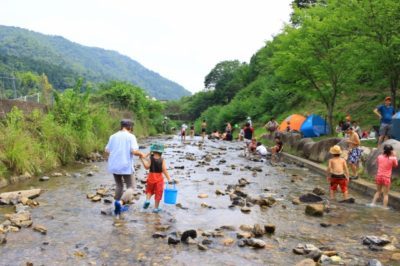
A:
[{"left": 273, "top": 1, "right": 358, "bottom": 133}]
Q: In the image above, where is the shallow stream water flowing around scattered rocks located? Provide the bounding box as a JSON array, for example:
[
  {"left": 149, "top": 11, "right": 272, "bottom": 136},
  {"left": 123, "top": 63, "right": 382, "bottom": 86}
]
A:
[{"left": 0, "top": 138, "right": 400, "bottom": 265}]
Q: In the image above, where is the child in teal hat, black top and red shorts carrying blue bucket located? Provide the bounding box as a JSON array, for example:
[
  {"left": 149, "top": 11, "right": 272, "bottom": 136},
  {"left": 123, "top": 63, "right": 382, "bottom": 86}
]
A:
[{"left": 140, "top": 144, "right": 171, "bottom": 213}]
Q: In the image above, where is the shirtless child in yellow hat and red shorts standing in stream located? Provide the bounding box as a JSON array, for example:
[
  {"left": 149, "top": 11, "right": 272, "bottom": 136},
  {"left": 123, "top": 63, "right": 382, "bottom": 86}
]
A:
[{"left": 326, "top": 145, "right": 349, "bottom": 200}]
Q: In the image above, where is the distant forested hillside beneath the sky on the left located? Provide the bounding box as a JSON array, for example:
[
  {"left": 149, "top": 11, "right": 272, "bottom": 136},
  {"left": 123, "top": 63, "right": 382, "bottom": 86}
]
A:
[{"left": 0, "top": 26, "right": 190, "bottom": 99}]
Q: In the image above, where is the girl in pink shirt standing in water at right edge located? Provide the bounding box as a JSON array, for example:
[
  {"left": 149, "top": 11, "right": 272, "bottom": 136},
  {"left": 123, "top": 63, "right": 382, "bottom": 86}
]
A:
[{"left": 371, "top": 145, "right": 398, "bottom": 208}]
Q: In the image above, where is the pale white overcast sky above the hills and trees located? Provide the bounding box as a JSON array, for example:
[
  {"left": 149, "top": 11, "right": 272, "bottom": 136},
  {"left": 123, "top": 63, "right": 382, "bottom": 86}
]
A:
[{"left": 0, "top": 0, "right": 292, "bottom": 93}]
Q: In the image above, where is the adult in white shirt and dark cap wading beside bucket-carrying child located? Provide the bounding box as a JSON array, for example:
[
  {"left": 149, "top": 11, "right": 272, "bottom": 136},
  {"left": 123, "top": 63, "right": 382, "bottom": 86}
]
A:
[{"left": 105, "top": 119, "right": 143, "bottom": 216}]
